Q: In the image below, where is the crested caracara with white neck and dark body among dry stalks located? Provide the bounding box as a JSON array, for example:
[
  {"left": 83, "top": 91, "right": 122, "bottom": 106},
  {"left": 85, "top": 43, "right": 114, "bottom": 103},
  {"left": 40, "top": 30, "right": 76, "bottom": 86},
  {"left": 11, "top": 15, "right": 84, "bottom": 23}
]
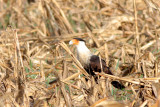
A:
[{"left": 69, "top": 38, "right": 124, "bottom": 89}]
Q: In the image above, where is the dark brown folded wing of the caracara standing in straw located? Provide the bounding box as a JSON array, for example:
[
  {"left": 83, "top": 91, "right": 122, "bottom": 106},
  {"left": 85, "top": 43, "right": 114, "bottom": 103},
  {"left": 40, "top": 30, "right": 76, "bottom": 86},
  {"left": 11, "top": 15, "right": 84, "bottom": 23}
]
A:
[{"left": 90, "top": 55, "right": 113, "bottom": 75}]
